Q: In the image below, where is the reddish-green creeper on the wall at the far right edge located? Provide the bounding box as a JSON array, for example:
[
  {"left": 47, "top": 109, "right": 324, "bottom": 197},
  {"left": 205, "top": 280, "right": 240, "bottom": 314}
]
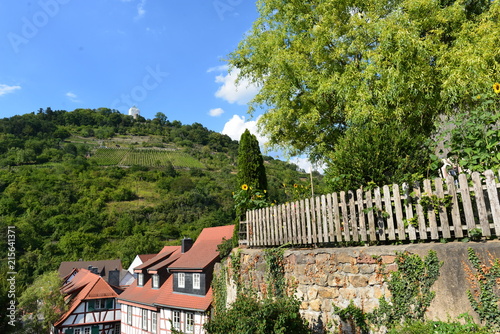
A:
[{"left": 464, "top": 248, "right": 500, "bottom": 331}]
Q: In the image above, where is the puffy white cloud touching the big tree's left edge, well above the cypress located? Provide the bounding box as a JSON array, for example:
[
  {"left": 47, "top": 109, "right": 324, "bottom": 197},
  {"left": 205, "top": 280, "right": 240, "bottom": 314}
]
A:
[{"left": 214, "top": 66, "right": 259, "bottom": 104}]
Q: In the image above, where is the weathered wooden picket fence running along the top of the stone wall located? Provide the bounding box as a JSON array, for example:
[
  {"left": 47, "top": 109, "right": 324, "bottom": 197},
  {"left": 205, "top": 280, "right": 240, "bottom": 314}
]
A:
[{"left": 240, "top": 170, "right": 500, "bottom": 247}]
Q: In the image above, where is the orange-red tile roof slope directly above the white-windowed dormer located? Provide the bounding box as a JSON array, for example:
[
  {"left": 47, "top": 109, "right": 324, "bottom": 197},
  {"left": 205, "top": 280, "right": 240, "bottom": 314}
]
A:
[{"left": 169, "top": 225, "right": 234, "bottom": 270}]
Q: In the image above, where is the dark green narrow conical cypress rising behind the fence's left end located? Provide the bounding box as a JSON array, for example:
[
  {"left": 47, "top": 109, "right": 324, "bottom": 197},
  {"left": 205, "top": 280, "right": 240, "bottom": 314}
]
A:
[{"left": 238, "top": 129, "right": 267, "bottom": 191}]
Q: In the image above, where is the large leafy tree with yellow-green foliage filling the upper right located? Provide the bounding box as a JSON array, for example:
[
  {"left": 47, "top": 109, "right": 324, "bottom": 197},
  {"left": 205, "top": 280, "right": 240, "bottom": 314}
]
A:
[{"left": 229, "top": 0, "right": 500, "bottom": 168}]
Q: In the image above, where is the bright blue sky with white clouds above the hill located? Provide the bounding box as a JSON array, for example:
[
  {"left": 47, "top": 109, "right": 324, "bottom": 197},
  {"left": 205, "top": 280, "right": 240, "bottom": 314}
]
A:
[{"left": 0, "top": 0, "right": 316, "bottom": 171}]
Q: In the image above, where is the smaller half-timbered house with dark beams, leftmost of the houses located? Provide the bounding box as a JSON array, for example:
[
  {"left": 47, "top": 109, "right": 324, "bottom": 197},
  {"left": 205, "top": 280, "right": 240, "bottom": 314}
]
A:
[{"left": 51, "top": 269, "right": 122, "bottom": 334}]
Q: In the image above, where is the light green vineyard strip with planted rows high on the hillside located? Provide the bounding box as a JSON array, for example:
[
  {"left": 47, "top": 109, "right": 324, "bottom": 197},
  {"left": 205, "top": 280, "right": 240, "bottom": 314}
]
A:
[{"left": 91, "top": 148, "right": 205, "bottom": 168}]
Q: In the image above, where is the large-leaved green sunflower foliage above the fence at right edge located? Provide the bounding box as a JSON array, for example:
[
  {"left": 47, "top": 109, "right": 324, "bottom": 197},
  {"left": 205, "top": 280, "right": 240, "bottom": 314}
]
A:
[{"left": 444, "top": 90, "right": 500, "bottom": 172}]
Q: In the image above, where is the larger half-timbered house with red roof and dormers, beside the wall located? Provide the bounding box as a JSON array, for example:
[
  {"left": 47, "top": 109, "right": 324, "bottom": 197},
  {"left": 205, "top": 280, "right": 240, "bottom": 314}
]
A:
[{"left": 118, "top": 225, "right": 234, "bottom": 334}]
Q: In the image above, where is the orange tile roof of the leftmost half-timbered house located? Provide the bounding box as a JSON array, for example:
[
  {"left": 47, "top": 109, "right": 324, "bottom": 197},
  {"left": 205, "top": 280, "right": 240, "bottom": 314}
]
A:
[{"left": 54, "top": 269, "right": 122, "bottom": 326}]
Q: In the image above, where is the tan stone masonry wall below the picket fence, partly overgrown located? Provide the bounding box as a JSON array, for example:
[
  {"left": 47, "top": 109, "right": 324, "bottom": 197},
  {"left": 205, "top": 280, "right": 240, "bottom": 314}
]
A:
[{"left": 221, "top": 240, "right": 500, "bottom": 333}]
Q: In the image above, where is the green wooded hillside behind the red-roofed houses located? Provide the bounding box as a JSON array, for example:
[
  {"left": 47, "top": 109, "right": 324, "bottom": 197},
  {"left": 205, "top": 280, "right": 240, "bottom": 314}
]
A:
[{"left": 0, "top": 108, "right": 324, "bottom": 327}]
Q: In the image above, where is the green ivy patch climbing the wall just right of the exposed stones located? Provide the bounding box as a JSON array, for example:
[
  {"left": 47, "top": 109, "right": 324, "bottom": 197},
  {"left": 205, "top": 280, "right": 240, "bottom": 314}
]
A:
[{"left": 370, "top": 251, "right": 442, "bottom": 328}]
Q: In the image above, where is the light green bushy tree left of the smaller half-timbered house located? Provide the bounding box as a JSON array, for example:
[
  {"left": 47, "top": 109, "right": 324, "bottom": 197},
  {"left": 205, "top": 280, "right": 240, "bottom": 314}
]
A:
[{"left": 19, "top": 271, "right": 68, "bottom": 333}]
